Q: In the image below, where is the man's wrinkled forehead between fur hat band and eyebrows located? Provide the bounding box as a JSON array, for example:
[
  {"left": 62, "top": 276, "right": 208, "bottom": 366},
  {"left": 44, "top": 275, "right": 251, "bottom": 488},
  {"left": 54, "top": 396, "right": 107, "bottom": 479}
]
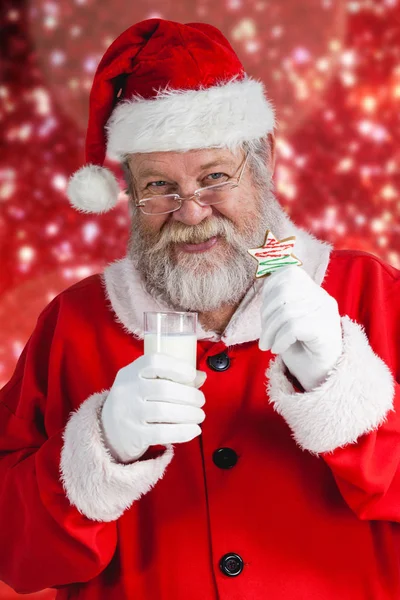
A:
[{"left": 127, "top": 148, "right": 244, "bottom": 179}]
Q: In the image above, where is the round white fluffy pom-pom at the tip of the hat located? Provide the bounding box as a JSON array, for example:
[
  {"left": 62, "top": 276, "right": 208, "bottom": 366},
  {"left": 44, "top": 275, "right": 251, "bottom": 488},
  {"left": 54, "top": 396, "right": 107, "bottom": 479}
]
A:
[{"left": 67, "top": 165, "right": 119, "bottom": 213}]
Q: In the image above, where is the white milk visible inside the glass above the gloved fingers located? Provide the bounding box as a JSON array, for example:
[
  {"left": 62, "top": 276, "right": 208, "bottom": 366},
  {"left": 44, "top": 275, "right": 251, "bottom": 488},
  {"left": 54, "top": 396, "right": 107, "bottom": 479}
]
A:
[{"left": 144, "top": 333, "right": 197, "bottom": 368}]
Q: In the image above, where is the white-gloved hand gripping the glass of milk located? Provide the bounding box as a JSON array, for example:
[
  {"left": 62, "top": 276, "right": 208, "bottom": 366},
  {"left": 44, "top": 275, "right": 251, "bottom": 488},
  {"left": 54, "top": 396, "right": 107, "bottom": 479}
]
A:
[{"left": 101, "top": 354, "right": 206, "bottom": 463}]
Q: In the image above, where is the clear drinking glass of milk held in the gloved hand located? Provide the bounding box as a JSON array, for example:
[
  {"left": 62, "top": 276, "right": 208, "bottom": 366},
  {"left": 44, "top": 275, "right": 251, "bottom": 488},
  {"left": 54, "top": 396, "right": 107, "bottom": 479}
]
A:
[{"left": 144, "top": 311, "right": 197, "bottom": 368}]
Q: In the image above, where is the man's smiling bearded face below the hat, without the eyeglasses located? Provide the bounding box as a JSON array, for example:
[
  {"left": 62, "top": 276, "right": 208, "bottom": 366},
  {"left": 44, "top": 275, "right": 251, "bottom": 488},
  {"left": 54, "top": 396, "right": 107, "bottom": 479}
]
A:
[{"left": 129, "top": 144, "right": 276, "bottom": 312}]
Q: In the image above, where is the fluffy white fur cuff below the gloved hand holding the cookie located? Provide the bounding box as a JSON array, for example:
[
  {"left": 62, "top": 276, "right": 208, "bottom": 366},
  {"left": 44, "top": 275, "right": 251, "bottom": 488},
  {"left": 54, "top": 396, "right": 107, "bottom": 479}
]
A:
[{"left": 266, "top": 317, "right": 394, "bottom": 454}]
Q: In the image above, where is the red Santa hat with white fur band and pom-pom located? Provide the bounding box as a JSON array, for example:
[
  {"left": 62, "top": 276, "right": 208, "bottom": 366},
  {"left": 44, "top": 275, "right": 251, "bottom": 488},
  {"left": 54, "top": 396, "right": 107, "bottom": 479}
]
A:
[{"left": 67, "top": 19, "right": 274, "bottom": 213}]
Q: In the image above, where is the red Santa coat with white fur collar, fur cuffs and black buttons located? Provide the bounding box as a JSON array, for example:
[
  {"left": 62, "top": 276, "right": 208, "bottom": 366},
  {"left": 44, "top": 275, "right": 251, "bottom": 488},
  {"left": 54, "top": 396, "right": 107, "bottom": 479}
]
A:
[{"left": 0, "top": 227, "right": 400, "bottom": 600}]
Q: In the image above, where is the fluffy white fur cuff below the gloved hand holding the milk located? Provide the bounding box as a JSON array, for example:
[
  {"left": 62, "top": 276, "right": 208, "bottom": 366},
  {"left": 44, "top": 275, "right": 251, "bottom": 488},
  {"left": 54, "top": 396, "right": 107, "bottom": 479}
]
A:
[{"left": 60, "top": 391, "right": 173, "bottom": 521}]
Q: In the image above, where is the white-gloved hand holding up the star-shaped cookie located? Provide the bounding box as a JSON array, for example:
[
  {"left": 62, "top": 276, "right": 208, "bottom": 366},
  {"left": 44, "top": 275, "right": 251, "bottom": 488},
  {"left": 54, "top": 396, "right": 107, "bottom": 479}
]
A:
[{"left": 259, "top": 266, "right": 342, "bottom": 391}]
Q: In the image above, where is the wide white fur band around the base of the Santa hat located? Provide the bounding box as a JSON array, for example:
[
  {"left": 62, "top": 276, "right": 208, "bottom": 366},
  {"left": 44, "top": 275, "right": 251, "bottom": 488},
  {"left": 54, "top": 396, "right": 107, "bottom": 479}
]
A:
[{"left": 106, "top": 77, "right": 275, "bottom": 160}]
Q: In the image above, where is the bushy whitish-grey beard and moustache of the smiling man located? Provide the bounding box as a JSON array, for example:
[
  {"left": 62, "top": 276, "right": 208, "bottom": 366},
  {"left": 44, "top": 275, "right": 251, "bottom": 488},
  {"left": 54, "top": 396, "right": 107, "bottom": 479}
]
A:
[{"left": 129, "top": 191, "right": 287, "bottom": 313}]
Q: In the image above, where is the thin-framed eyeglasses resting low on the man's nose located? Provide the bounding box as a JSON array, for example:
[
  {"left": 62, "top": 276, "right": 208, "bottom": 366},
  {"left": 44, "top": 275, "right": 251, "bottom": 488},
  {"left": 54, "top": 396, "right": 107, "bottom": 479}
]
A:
[{"left": 135, "top": 154, "right": 249, "bottom": 215}]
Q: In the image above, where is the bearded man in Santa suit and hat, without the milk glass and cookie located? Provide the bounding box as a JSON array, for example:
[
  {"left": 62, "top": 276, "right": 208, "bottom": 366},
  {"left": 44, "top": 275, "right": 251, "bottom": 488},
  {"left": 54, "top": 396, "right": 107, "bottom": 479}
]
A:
[{"left": 0, "top": 19, "right": 400, "bottom": 600}]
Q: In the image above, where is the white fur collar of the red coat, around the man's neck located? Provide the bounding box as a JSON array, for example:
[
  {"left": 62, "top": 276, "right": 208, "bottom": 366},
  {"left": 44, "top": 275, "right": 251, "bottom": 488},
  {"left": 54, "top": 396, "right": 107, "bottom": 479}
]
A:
[{"left": 103, "top": 223, "right": 331, "bottom": 346}]
